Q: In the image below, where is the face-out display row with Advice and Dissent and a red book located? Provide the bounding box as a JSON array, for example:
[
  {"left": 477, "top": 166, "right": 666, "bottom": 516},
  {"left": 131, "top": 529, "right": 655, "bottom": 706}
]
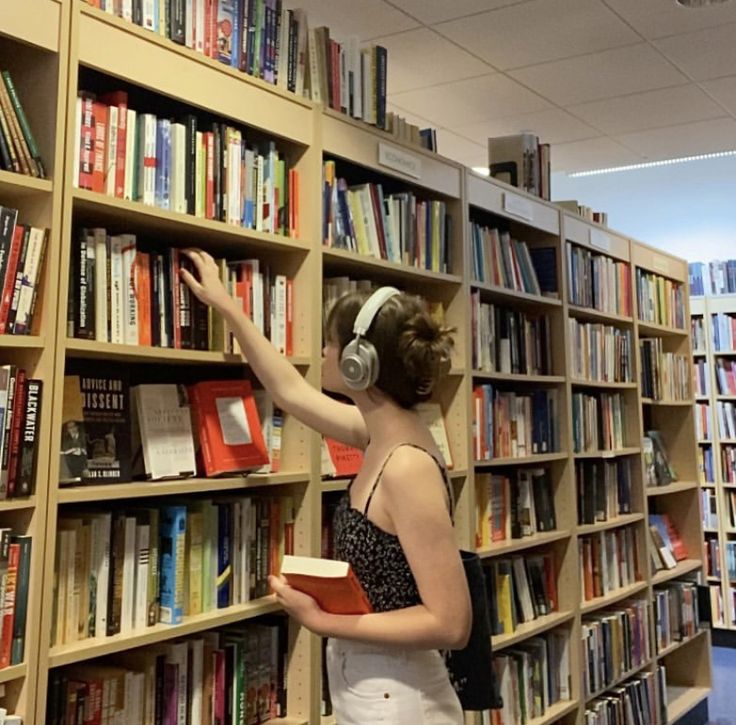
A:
[{"left": 59, "top": 370, "right": 283, "bottom": 484}]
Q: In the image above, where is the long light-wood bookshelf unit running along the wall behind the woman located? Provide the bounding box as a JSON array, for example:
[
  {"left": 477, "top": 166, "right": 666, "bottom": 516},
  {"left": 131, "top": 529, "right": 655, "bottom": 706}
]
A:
[{"left": 0, "top": 0, "right": 712, "bottom": 725}]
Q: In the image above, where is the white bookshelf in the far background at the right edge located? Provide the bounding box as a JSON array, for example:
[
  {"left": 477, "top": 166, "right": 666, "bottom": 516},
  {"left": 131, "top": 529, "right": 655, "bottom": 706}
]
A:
[{"left": 690, "top": 295, "right": 736, "bottom": 630}]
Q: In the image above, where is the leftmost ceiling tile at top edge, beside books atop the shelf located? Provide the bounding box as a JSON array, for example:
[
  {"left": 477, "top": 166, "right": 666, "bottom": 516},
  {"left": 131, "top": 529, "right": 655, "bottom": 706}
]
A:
[{"left": 289, "top": 0, "right": 419, "bottom": 40}]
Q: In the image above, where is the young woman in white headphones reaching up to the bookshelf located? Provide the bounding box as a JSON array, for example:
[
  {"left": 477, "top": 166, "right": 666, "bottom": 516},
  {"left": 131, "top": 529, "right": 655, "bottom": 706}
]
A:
[{"left": 182, "top": 249, "right": 471, "bottom": 725}]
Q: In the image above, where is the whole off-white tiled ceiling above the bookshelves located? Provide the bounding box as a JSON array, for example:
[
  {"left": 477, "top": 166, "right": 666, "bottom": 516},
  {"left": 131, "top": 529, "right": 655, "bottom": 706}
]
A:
[{"left": 294, "top": 0, "right": 736, "bottom": 172}]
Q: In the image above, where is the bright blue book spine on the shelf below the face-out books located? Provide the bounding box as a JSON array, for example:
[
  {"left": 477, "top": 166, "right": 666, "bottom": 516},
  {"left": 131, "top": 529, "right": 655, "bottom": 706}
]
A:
[{"left": 160, "top": 506, "right": 187, "bottom": 624}]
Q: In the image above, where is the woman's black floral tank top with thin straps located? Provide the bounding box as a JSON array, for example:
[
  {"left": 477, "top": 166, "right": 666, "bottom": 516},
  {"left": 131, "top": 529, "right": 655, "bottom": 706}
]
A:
[{"left": 333, "top": 443, "right": 453, "bottom": 612}]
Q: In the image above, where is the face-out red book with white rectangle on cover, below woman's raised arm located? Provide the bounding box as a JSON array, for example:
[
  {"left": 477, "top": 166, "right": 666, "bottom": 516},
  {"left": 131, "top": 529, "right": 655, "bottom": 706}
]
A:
[{"left": 189, "top": 380, "right": 268, "bottom": 476}]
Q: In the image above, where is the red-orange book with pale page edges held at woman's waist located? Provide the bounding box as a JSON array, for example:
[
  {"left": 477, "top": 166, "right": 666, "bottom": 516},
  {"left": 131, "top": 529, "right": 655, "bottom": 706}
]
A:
[{"left": 281, "top": 554, "right": 373, "bottom": 614}]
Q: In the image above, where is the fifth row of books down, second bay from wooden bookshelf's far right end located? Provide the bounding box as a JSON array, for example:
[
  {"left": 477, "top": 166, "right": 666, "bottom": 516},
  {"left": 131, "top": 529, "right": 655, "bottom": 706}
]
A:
[{"left": 578, "top": 526, "right": 642, "bottom": 602}]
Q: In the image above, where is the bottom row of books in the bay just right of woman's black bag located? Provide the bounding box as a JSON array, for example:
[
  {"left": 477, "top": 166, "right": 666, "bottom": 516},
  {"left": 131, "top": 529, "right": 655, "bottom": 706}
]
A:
[{"left": 492, "top": 630, "right": 572, "bottom": 725}]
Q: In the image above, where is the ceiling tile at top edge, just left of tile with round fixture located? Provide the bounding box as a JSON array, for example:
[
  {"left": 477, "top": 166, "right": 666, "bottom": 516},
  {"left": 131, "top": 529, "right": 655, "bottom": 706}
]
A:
[{"left": 435, "top": 0, "right": 640, "bottom": 70}]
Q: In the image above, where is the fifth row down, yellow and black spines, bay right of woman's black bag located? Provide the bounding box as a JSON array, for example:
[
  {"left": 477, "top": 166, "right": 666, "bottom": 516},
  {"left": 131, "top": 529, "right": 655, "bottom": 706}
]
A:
[{"left": 485, "top": 552, "right": 559, "bottom": 635}]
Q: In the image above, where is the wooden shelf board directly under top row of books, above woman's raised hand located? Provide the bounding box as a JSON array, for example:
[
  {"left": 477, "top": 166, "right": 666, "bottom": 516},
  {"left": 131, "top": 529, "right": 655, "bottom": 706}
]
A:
[{"left": 72, "top": 189, "right": 309, "bottom": 253}]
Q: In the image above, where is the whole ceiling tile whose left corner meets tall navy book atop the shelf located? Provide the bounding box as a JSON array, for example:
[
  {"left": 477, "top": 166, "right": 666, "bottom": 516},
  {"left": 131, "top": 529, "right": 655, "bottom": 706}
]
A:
[{"left": 391, "top": 73, "right": 550, "bottom": 128}]
